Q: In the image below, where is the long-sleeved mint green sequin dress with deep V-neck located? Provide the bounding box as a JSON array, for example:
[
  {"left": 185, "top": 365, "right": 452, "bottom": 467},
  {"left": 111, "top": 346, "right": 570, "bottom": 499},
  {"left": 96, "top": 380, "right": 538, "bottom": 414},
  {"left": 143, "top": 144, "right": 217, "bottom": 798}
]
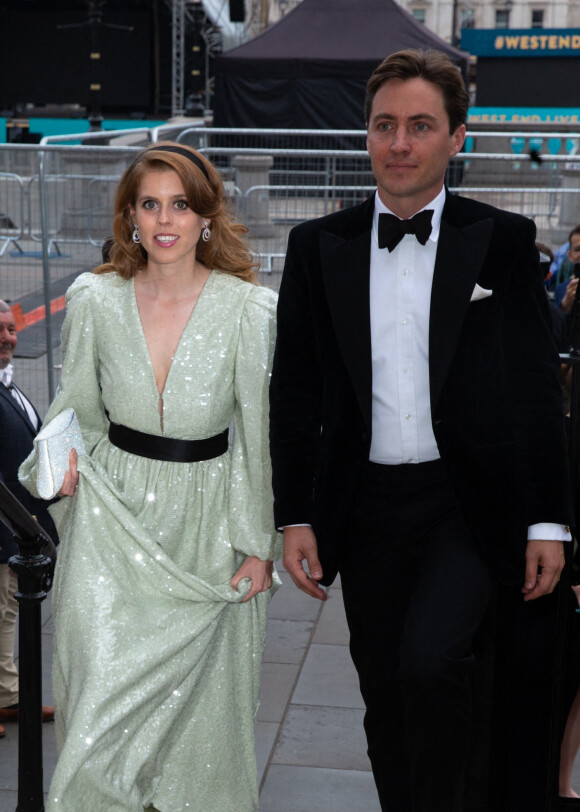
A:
[{"left": 20, "top": 271, "right": 281, "bottom": 812}]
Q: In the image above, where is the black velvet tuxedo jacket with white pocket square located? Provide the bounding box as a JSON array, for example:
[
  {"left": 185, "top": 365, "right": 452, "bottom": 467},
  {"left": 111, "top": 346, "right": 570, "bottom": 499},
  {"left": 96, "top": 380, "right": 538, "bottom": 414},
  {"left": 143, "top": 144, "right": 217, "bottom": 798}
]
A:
[{"left": 270, "top": 194, "right": 572, "bottom": 584}]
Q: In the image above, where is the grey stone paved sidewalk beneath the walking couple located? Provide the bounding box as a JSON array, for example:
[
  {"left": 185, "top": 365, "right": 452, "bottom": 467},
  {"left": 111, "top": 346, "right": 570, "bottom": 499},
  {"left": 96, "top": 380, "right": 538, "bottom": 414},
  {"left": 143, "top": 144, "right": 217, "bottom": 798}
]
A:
[{"left": 0, "top": 572, "right": 380, "bottom": 812}]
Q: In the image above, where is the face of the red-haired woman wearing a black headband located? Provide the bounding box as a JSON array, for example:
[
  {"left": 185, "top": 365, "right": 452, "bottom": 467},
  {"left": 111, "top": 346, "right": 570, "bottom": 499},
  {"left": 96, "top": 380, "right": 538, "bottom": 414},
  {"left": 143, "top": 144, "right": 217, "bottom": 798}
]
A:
[{"left": 129, "top": 169, "right": 209, "bottom": 267}]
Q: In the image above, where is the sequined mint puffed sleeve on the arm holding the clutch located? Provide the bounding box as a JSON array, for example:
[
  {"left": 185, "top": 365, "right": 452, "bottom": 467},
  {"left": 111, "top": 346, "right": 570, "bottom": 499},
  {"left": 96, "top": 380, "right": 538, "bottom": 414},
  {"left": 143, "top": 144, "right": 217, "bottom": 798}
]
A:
[{"left": 18, "top": 273, "right": 108, "bottom": 496}]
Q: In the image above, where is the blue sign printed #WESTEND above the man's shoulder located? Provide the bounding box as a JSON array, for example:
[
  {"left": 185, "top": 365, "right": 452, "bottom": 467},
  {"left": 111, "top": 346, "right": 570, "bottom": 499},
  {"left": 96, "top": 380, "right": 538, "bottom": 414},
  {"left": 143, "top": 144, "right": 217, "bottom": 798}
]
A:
[{"left": 461, "top": 28, "right": 580, "bottom": 57}]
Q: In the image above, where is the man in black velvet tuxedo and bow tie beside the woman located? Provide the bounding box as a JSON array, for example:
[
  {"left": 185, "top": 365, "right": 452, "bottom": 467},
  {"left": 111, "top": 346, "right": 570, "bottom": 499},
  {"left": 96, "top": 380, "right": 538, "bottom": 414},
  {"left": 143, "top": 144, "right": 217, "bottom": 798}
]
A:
[{"left": 271, "top": 51, "right": 571, "bottom": 812}]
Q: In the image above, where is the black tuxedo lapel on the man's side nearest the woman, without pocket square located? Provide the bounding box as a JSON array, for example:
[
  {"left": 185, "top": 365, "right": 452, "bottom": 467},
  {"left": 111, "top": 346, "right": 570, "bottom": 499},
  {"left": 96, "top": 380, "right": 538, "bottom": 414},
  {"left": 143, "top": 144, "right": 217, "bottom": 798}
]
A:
[{"left": 320, "top": 216, "right": 372, "bottom": 430}]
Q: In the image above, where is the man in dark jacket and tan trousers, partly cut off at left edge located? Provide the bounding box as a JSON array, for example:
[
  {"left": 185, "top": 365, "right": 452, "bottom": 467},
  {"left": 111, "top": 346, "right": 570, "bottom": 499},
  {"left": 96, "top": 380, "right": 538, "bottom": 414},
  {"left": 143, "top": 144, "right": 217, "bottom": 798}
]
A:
[{"left": 0, "top": 299, "right": 57, "bottom": 737}]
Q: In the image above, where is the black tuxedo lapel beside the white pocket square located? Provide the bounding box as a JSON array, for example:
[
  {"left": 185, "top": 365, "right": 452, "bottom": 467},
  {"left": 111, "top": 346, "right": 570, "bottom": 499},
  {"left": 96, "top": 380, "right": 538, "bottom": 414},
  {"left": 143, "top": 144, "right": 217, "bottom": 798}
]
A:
[{"left": 429, "top": 210, "right": 493, "bottom": 411}]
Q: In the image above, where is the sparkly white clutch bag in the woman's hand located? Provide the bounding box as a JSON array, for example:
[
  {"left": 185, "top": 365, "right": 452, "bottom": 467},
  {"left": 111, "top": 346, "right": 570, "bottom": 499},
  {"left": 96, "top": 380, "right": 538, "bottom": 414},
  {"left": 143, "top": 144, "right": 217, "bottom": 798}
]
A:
[{"left": 34, "top": 409, "right": 87, "bottom": 499}]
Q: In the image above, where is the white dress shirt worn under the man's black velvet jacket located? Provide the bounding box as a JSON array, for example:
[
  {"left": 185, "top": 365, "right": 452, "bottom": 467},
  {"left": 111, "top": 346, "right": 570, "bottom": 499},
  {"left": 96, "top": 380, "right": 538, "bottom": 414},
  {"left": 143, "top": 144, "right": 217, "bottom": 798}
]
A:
[{"left": 369, "top": 189, "right": 571, "bottom": 541}]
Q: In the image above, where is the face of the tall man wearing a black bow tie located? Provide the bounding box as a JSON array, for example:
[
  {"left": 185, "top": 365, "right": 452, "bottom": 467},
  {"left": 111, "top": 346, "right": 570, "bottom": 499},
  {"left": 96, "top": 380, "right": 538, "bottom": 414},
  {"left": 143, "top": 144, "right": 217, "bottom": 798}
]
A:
[{"left": 367, "top": 78, "right": 465, "bottom": 217}]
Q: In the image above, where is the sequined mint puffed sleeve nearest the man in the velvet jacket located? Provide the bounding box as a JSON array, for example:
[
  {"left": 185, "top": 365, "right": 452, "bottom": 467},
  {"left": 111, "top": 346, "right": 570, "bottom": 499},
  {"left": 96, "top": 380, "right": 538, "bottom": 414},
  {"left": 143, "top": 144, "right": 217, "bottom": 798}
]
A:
[{"left": 229, "top": 287, "right": 282, "bottom": 561}]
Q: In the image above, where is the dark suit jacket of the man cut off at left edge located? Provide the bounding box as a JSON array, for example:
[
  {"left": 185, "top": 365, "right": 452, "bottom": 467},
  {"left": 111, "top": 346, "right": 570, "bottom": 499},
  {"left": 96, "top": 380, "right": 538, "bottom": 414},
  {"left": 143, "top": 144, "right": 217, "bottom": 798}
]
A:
[{"left": 0, "top": 383, "right": 58, "bottom": 564}]
